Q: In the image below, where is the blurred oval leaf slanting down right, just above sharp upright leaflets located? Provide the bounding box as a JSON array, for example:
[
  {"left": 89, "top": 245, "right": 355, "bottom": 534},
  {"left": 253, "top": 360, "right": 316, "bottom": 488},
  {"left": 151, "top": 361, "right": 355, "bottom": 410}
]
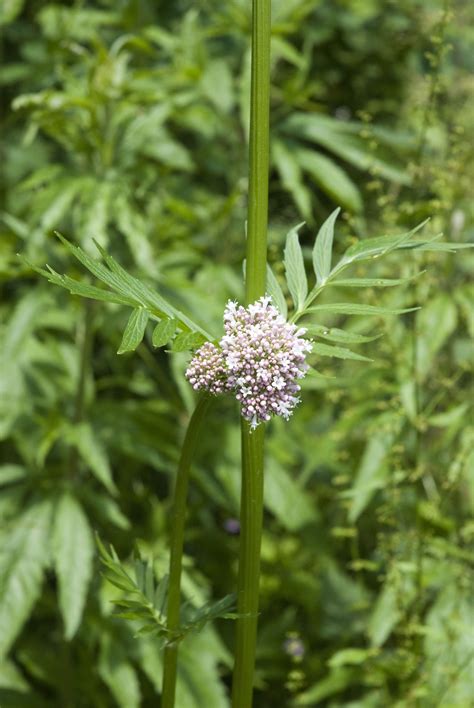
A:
[{"left": 294, "top": 148, "right": 362, "bottom": 213}]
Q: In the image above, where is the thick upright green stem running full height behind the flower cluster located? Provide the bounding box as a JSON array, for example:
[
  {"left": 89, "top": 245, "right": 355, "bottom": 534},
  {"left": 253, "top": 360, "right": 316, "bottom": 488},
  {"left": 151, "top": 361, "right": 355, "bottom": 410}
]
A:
[{"left": 232, "top": 0, "right": 271, "bottom": 708}]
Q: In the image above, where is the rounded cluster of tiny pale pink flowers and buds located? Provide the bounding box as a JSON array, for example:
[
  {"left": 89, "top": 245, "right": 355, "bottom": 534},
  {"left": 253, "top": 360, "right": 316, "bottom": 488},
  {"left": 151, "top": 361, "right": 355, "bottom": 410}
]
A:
[{"left": 186, "top": 297, "right": 311, "bottom": 428}]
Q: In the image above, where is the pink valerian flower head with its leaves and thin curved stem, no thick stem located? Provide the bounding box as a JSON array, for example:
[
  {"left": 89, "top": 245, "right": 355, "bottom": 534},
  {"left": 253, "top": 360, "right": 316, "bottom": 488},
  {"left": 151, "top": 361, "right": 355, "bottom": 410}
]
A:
[{"left": 26, "top": 210, "right": 470, "bottom": 705}]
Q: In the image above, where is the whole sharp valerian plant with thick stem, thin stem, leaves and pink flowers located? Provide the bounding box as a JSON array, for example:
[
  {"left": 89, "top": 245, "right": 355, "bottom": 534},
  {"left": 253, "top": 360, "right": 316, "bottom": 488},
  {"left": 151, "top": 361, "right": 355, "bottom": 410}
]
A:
[{"left": 12, "top": 2, "right": 472, "bottom": 708}]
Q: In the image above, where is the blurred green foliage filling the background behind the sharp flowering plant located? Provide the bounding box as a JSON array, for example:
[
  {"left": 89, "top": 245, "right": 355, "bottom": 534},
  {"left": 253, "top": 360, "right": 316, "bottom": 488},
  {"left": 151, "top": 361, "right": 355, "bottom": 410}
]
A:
[{"left": 0, "top": 0, "right": 474, "bottom": 708}]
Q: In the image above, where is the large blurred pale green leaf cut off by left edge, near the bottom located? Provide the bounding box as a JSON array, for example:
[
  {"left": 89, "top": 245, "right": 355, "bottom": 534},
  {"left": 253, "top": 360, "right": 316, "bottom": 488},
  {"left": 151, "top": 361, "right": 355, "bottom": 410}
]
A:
[{"left": 0, "top": 501, "right": 51, "bottom": 657}]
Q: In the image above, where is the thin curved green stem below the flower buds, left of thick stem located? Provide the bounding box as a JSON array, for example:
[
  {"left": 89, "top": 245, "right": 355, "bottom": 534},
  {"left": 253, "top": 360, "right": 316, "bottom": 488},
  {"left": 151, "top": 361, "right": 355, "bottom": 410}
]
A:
[{"left": 161, "top": 395, "right": 211, "bottom": 708}]
